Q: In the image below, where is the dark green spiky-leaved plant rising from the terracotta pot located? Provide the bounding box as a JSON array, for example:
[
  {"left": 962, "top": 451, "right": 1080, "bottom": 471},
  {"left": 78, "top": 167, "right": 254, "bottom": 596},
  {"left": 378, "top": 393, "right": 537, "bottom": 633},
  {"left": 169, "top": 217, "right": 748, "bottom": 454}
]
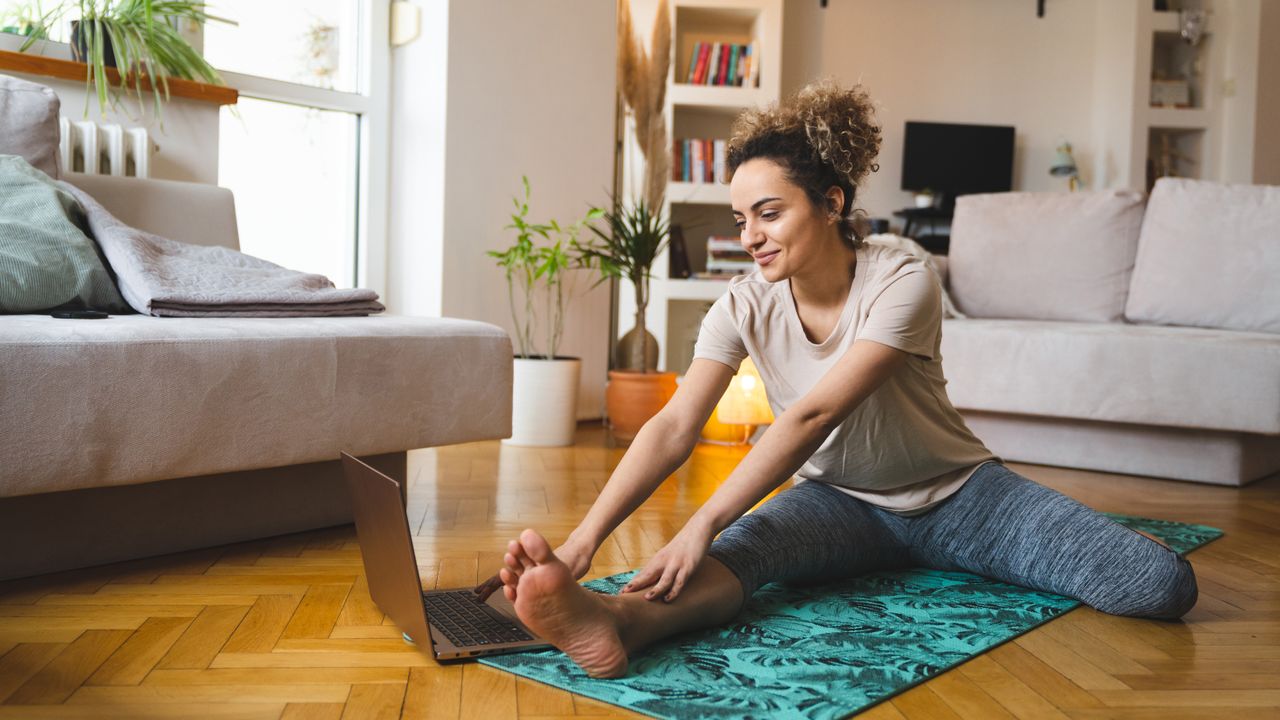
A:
[{"left": 579, "top": 199, "right": 671, "bottom": 372}]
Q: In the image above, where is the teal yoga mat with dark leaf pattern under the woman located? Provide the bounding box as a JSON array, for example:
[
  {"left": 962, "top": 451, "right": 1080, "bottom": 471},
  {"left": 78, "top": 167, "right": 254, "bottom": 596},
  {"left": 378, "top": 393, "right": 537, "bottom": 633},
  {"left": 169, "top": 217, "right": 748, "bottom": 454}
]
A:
[{"left": 481, "top": 515, "right": 1222, "bottom": 720}]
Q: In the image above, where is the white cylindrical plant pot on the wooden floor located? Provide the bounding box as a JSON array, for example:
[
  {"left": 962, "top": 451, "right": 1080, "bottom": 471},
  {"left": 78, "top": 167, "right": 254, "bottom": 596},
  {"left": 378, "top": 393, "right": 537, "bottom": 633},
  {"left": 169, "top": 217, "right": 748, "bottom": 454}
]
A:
[{"left": 502, "top": 357, "right": 582, "bottom": 447}]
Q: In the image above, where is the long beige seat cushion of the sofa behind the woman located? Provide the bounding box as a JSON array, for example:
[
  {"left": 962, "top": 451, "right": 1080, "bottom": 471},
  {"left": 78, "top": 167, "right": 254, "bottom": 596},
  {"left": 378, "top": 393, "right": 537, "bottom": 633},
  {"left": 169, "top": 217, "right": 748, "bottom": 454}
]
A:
[{"left": 942, "top": 319, "right": 1280, "bottom": 434}]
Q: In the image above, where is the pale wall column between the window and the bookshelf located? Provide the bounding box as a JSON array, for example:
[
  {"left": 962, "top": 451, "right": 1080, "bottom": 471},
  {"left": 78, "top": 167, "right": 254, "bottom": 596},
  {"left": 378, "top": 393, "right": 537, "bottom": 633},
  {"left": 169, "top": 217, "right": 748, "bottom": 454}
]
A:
[{"left": 388, "top": 0, "right": 614, "bottom": 418}]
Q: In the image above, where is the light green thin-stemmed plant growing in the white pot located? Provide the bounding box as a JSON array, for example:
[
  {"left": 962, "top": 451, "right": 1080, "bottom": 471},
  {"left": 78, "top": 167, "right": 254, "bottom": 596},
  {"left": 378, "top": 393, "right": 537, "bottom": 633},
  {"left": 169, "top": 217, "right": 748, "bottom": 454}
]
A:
[{"left": 488, "top": 177, "right": 602, "bottom": 360}]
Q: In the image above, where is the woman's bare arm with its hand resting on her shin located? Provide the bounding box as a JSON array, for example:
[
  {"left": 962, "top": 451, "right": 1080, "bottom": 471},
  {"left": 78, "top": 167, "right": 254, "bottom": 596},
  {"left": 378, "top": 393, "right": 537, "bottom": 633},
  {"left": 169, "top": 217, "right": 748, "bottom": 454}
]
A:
[{"left": 623, "top": 340, "right": 909, "bottom": 601}]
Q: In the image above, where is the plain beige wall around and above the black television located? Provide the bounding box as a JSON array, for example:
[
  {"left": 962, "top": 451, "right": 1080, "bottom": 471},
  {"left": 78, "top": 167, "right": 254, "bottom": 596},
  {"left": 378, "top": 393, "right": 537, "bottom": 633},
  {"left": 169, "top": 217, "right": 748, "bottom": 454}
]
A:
[{"left": 808, "top": 0, "right": 1097, "bottom": 217}]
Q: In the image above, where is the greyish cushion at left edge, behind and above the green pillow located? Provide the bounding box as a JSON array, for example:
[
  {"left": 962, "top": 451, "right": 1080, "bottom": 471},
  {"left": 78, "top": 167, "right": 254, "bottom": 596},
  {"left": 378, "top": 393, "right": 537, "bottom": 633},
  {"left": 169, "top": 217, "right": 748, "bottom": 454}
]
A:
[{"left": 0, "top": 76, "right": 60, "bottom": 178}]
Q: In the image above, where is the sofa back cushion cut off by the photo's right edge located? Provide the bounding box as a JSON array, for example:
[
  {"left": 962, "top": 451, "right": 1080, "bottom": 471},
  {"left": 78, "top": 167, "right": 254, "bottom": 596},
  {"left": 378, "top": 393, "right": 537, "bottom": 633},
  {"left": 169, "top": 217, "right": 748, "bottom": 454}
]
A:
[{"left": 1125, "top": 178, "right": 1280, "bottom": 333}]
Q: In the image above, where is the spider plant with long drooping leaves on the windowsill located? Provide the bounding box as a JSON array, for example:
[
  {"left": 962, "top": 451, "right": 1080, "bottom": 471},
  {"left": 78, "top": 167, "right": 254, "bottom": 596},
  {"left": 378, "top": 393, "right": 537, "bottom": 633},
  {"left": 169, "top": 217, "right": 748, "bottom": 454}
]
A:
[{"left": 22, "top": 0, "right": 236, "bottom": 117}]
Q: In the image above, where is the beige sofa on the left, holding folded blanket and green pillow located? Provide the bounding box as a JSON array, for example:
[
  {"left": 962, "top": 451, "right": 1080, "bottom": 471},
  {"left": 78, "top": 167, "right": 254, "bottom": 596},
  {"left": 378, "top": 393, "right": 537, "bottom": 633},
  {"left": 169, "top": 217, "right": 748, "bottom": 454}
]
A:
[{"left": 0, "top": 174, "right": 512, "bottom": 579}]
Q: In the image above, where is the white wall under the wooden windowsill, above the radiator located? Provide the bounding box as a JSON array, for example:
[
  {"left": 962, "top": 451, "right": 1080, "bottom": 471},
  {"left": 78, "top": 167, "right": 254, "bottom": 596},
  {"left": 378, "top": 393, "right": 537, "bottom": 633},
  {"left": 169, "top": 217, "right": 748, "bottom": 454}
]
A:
[{"left": 0, "top": 33, "right": 220, "bottom": 184}]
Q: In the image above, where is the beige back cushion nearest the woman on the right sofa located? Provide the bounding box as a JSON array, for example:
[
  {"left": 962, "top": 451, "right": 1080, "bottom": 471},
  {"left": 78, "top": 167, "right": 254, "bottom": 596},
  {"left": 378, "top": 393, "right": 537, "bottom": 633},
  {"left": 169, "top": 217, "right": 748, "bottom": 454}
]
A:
[{"left": 948, "top": 191, "right": 1142, "bottom": 322}]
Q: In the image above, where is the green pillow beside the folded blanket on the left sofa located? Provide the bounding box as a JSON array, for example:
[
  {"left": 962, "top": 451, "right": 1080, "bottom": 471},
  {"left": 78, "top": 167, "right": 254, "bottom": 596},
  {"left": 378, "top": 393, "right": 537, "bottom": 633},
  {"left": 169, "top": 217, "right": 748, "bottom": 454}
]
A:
[{"left": 0, "top": 155, "right": 132, "bottom": 313}]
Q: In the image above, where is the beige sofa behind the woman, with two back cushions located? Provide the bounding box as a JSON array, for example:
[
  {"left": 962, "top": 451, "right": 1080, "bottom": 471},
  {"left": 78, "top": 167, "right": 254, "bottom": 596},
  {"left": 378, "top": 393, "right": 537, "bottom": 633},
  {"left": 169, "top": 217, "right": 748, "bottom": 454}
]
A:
[{"left": 942, "top": 179, "right": 1280, "bottom": 486}]
